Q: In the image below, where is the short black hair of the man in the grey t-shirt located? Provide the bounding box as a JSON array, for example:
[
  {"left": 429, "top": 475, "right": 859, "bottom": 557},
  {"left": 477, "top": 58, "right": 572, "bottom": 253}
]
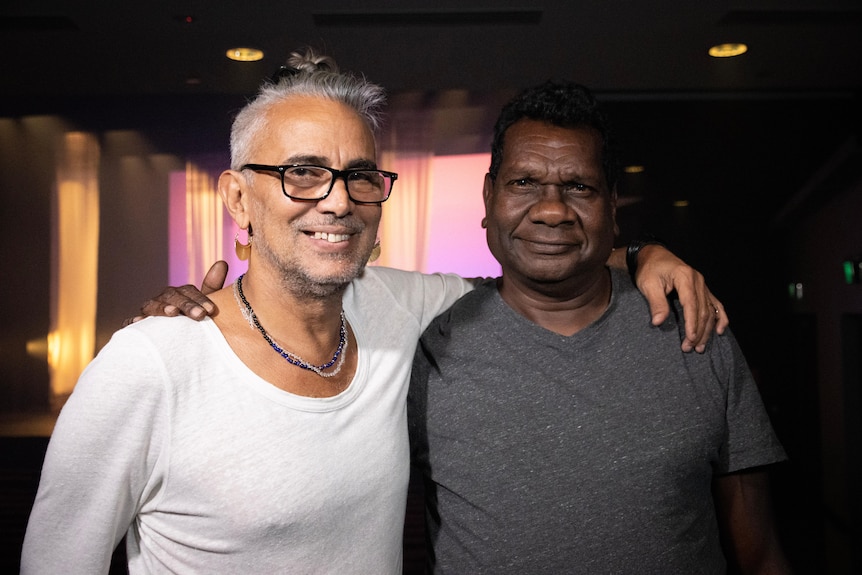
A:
[{"left": 488, "top": 81, "right": 620, "bottom": 190}]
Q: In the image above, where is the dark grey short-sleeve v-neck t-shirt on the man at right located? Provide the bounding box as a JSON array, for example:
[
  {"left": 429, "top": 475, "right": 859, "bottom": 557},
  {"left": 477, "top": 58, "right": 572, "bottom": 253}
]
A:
[{"left": 408, "top": 271, "right": 785, "bottom": 575}]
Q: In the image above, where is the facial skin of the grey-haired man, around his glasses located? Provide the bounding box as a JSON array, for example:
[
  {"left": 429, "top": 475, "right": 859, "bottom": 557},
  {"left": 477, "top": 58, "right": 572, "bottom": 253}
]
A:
[{"left": 236, "top": 96, "right": 381, "bottom": 299}]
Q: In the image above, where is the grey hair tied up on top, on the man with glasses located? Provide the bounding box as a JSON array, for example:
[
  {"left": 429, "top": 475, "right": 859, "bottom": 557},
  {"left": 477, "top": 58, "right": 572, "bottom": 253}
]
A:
[{"left": 230, "top": 48, "right": 386, "bottom": 170}]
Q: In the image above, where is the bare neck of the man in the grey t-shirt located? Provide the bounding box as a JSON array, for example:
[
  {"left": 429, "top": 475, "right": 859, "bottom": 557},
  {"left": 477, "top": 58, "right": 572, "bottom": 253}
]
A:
[{"left": 497, "top": 269, "right": 611, "bottom": 336}]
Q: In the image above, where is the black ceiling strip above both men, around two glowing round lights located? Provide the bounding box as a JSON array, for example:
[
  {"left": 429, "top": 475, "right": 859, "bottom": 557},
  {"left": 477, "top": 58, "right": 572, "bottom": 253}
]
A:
[{"left": 0, "top": 0, "right": 862, "bottom": 94}]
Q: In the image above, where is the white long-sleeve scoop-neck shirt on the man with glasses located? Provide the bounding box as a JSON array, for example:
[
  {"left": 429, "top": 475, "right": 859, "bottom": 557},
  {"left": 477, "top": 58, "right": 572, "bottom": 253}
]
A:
[{"left": 22, "top": 268, "right": 471, "bottom": 575}]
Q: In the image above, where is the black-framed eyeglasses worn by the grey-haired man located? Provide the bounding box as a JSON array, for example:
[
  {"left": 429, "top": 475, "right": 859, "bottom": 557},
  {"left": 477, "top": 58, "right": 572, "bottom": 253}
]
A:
[{"left": 240, "top": 164, "right": 398, "bottom": 204}]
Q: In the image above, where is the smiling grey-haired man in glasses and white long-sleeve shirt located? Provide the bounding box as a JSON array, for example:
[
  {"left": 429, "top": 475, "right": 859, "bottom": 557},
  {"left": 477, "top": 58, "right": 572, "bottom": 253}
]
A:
[{"left": 22, "top": 52, "right": 726, "bottom": 575}]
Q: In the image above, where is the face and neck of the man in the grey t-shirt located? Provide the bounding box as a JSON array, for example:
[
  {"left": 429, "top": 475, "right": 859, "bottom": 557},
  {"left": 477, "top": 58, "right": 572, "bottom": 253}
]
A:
[{"left": 484, "top": 119, "right": 617, "bottom": 335}]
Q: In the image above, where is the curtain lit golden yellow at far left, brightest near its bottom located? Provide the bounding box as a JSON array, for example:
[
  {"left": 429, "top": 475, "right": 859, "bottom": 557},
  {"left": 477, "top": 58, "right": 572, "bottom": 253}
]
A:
[{"left": 48, "top": 132, "right": 99, "bottom": 403}]
